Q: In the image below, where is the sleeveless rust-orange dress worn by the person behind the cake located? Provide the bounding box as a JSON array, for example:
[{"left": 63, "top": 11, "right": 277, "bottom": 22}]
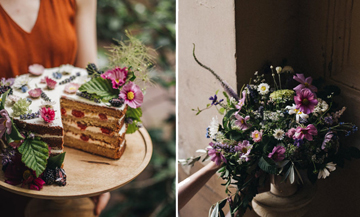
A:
[{"left": 0, "top": 0, "right": 78, "bottom": 78}]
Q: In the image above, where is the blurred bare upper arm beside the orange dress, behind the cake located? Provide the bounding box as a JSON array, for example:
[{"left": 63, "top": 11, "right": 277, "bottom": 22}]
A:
[{"left": 75, "top": 0, "right": 97, "bottom": 68}]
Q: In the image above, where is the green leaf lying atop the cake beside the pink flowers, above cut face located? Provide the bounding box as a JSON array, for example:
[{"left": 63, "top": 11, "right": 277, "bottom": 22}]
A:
[{"left": 79, "top": 77, "right": 119, "bottom": 99}]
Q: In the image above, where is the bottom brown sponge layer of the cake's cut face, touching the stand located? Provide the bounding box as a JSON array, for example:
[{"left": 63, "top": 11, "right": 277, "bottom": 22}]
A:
[{"left": 64, "top": 136, "right": 126, "bottom": 159}]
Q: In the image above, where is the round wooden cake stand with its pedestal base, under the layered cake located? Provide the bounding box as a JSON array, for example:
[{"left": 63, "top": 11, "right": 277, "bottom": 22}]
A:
[{"left": 0, "top": 128, "right": 153, "bottom": 217}]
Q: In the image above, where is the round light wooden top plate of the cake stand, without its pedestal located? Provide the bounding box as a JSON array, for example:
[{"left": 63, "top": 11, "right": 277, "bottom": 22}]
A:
[{"left": 0, "top": 128, "right": 153, "bottom": 199}]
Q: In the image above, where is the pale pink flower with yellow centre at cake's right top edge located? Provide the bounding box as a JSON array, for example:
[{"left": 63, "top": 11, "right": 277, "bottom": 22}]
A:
[{"left": 119, "top": 81, "right": 144, "bottom": 108}]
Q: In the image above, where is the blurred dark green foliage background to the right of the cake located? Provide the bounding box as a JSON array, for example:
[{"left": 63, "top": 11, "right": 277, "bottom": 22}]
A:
[{"left": 97, "top": 0, "right": 176, "bottom": 217}]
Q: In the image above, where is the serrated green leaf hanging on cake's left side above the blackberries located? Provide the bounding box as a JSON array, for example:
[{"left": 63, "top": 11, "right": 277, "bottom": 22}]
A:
[{"left": 18, "top": 138, "right": 49, "bottom": 177}]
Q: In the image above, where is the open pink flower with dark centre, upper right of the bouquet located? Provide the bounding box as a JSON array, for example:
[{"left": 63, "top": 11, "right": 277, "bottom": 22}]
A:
[{"left": 294, "top": 88, "right": 318, "bottom": 114}]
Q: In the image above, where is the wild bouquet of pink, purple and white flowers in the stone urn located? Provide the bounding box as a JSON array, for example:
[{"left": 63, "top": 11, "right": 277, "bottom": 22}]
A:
[{"left": 180, "top": 47, "right": 360, "bottom": 216}]
